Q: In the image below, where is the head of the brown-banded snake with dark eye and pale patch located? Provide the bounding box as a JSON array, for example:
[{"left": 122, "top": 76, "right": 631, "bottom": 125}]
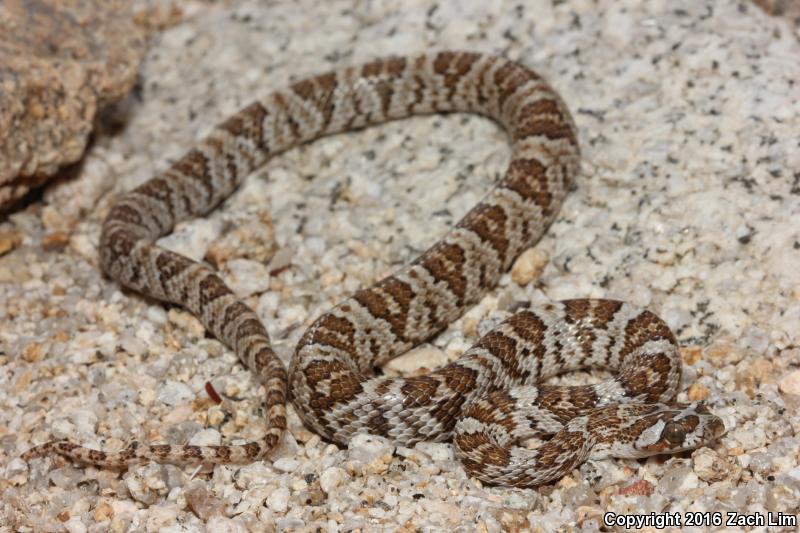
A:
[{"left": 633, "top": 402, "right": 725, "bottom": 457}]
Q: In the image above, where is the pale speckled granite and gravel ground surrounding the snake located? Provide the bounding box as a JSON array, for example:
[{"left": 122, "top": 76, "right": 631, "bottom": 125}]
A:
[{"left": 0, "top": 0, "right": 800, "bottom": 532}]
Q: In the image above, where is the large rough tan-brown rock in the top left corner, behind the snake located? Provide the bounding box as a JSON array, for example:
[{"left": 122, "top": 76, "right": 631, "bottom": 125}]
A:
[{"left": 0, "top": 0, "right": 145, "bottom": 210}]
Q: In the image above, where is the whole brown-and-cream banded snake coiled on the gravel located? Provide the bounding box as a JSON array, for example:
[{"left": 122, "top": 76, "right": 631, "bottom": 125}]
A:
[{"left": 23, "top": 51, "right": 724, "bottom": 487}]
